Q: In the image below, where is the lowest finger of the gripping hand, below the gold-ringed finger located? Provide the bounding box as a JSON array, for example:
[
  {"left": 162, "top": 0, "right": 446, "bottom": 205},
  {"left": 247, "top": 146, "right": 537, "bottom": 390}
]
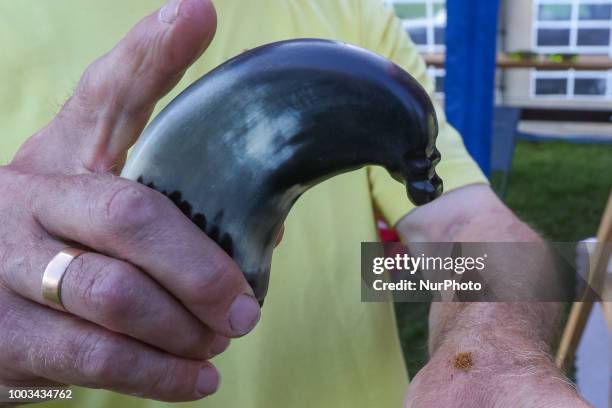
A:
[{"left": 0, "top": 290, "right": 219, "bottom": 401}]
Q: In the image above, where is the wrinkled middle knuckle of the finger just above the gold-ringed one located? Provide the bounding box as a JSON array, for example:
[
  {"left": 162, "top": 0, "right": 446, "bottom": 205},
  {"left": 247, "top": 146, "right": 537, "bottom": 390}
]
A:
[{"left": 100, "top": 180, "right": 163, "bottom": 235}]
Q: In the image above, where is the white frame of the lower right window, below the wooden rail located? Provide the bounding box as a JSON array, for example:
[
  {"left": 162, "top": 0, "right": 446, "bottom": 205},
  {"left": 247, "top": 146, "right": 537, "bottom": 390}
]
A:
[{"left": 529, "top": 69, "right": 612, "bottom": 102}]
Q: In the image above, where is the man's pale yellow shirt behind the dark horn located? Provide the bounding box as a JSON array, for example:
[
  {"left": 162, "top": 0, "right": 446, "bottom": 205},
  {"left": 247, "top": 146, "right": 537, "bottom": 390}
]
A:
[{"left": 0, "top": 0, "right": 485, "bottom": 408}]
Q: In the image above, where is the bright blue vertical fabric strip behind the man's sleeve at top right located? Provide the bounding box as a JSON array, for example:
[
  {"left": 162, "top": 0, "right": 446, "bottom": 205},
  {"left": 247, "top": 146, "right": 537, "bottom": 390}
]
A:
[{"left": 445, "top": 0, "right": 499, "bottom": 175}]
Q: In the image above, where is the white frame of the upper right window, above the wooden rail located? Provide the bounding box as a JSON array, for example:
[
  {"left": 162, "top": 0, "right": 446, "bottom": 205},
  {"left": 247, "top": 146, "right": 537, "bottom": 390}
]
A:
[{"left": 531, "top": 0, "right": 612, "bottom": 57}]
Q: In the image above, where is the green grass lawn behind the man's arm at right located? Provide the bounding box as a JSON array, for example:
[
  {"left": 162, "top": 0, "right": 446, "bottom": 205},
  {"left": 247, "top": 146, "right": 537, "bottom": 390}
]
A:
[{"left": 396, "top": 142, "right": 612, "bottom": 376}]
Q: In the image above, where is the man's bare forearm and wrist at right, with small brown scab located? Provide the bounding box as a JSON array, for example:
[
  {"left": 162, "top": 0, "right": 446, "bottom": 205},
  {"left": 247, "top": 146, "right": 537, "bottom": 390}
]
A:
[{"left": 398, "top": 185, "right": 588, "bottom": 408}]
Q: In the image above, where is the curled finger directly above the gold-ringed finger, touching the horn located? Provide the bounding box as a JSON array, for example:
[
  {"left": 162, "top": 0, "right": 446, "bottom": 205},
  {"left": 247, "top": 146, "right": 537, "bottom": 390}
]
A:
[{"left": 31, "top": 175, "right": 260, "bottom": 337}]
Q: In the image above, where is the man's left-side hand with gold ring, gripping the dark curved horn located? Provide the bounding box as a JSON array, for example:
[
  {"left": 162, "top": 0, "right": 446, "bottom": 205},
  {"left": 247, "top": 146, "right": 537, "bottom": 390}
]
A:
[{"left": 0, "top": 0, "right": 260, "bottom": 401}]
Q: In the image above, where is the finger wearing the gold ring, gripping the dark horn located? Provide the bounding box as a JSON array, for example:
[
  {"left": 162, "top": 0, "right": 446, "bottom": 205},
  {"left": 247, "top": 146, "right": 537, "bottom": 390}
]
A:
[{"left": 5, "top": 239, "right": 219, "bottom": 358}]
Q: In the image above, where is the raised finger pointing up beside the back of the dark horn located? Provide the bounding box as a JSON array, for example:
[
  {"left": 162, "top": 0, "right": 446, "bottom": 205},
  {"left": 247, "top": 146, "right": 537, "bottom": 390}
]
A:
[{"left": 16, "top": 0, "right": 216, "bottom": 173}]
